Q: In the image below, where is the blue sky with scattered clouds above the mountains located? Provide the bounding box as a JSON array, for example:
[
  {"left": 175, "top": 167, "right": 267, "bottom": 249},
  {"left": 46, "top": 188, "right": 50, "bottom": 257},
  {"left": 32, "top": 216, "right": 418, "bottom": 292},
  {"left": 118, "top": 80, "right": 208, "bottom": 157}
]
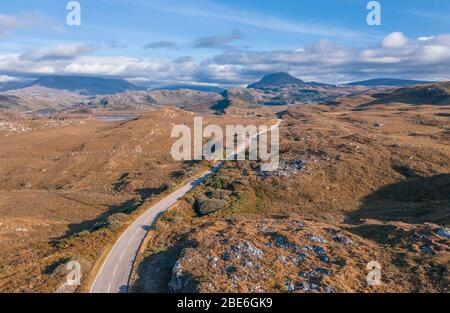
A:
[{"left": 0, "top": 0, "right": 450, "bottom": 86}]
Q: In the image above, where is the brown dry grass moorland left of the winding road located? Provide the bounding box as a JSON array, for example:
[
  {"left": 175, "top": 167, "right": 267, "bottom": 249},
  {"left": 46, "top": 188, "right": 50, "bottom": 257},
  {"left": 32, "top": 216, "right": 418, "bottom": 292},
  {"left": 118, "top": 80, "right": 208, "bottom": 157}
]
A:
[{"left": 0, "top": 109, "right": 266, "bottom": 292}]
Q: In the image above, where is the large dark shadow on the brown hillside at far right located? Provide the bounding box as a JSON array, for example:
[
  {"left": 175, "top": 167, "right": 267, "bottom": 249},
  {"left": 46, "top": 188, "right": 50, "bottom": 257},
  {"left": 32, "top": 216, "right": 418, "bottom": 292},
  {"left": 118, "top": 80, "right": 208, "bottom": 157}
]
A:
[{"left": 349, "top": 172, "right": 450, "bottom": 225}]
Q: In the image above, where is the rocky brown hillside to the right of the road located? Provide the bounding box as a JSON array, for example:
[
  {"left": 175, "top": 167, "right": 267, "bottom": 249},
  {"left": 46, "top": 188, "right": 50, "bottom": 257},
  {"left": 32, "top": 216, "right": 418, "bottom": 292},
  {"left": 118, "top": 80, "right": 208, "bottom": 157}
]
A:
[{"left": 133, "top": 101, "right": 450, "bottom": 292}]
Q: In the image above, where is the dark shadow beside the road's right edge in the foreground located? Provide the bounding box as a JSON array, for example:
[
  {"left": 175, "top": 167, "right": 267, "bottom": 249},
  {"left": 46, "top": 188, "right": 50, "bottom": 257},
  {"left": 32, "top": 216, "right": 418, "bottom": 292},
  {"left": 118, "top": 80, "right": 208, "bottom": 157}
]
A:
[{"left": 132, "top": 239, "right": 198, "bottom": 293}]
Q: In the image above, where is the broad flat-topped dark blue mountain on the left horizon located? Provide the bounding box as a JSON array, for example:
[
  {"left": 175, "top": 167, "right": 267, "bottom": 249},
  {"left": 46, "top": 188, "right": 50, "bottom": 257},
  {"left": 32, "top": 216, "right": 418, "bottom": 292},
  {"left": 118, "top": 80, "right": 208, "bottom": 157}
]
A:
[{"left": 30, "top": 76, "right": 145, "bottom": 95}]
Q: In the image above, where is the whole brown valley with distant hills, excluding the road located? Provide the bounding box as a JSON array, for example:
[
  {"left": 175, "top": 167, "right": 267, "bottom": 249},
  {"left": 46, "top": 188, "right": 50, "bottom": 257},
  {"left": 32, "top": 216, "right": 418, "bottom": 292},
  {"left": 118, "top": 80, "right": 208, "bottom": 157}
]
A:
[{"left": 0, "top": 73, "right": 450, "bottom": 292}]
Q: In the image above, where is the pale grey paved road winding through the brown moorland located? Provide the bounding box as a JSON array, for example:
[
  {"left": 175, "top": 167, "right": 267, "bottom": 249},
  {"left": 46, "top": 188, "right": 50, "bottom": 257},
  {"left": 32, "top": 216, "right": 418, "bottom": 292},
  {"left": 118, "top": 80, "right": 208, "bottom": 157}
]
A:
[{"left": 91, "top": 121, "right": 281, "bottom": 293}]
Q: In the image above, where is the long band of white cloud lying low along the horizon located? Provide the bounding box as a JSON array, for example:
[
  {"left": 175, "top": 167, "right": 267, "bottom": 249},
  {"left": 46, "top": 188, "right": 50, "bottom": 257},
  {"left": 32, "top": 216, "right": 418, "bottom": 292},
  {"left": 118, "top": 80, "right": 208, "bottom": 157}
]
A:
[{"left": 0, "top": 34, "right": 450, "bottom": 85}]
